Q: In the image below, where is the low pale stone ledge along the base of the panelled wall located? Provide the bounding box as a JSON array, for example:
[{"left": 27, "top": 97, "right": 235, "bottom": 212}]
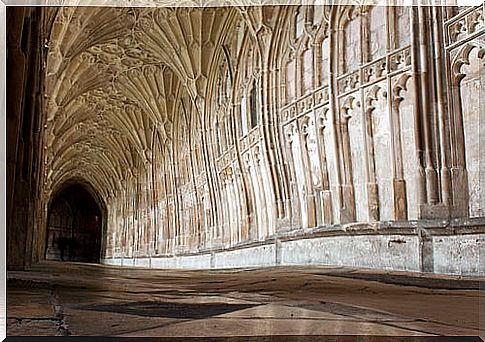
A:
[{"left": 102, "top": 220, "right": 485, "bottom": 276}]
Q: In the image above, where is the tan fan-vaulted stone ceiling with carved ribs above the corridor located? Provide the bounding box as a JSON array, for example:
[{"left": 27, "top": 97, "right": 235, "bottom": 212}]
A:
[{"left": 44, "top": 7, "right": 244, "bottom": 200}]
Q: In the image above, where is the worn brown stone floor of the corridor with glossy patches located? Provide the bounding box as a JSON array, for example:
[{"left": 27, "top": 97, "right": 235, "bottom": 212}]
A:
[{"left": 7, "top": 262, "right": 485, "bottom": 338}]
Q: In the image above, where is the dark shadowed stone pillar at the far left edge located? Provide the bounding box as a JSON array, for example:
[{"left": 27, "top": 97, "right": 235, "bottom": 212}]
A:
[{"left": 6, "top": 6, "right": 42, "bottom": 268}]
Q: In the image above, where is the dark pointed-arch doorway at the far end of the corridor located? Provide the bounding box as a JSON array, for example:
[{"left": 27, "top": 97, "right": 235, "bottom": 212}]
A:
[{"left": 46, "top": 184, "right": 102, "bottom": 262}]
